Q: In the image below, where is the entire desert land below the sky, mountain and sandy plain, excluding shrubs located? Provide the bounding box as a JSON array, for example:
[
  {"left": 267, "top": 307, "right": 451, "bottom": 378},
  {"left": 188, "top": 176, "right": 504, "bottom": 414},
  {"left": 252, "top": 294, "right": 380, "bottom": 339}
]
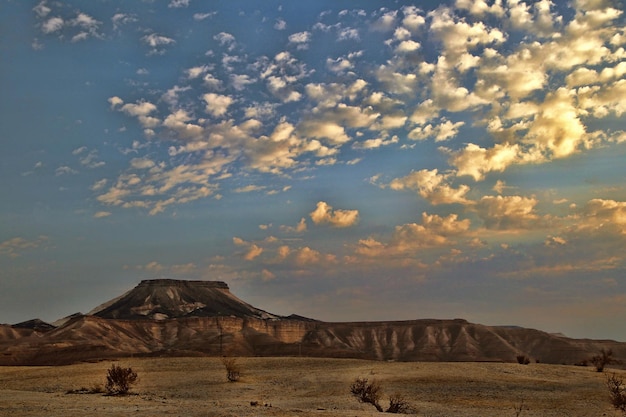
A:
[{"left": 0, "top": 279, "right": 626, "bottom": 417}]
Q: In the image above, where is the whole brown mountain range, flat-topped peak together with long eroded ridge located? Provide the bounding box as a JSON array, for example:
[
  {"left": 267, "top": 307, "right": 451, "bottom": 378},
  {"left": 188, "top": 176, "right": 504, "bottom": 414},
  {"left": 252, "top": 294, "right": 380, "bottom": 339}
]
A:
[{"left": 0, "top": 279, "right": 626, "bottom": 365}]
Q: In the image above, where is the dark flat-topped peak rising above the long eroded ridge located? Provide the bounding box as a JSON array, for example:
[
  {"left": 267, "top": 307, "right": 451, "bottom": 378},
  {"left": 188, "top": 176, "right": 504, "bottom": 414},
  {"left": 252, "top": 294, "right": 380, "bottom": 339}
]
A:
[{"left": 89, "top": 279, "right": 278, "bottom": 320}]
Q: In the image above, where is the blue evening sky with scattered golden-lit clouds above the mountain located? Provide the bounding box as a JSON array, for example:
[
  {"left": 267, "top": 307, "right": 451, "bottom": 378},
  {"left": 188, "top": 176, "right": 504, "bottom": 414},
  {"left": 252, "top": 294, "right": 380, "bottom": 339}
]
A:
[{"left": 0, "top": 0, "right": 626, "bottom": 341}]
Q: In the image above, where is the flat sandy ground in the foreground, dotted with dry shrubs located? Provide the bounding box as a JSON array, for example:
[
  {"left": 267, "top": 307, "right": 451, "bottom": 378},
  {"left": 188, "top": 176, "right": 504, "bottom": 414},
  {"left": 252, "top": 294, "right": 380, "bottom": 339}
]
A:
[{"left": 0, "top": 358, "right": 626, "bottom": 417}]
